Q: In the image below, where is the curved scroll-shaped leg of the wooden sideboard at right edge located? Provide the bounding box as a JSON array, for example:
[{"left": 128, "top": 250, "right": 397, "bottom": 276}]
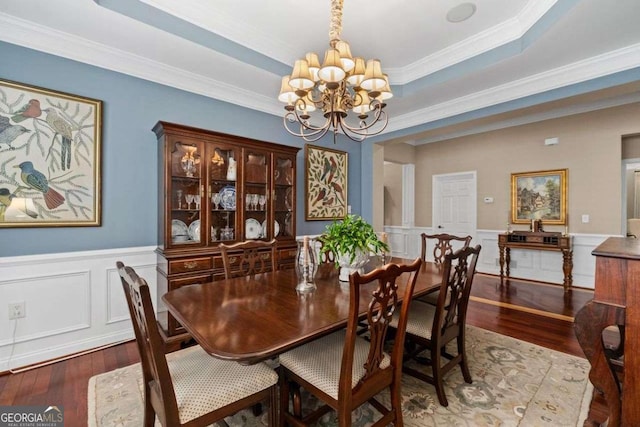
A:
[{"left": 573, "top": 301, "right": 625, "bottom": 427}]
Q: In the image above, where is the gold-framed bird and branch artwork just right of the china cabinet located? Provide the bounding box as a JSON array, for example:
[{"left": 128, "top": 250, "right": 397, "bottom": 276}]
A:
[{"left": 304, "top": 144, "right": 348, "bottom": 221}]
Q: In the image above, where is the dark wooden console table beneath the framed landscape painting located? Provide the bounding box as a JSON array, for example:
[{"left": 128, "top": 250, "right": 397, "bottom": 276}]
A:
[{"left": 498, "top": 231, "right": 573, "bottom": 293}]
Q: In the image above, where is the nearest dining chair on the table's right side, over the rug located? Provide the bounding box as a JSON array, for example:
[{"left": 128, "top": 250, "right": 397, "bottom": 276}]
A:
[{"left": 280, "top": 258, "right": 422, "bottom": 427}]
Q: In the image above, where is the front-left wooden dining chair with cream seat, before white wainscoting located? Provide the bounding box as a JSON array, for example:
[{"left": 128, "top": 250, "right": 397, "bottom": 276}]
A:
[{"left": 116, "top": 261, "right": 278, "bottom": 427}]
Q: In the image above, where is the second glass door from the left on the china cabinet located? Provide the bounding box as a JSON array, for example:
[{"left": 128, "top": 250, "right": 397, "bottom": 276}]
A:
[{"left": 207, "top": 144, "right": 241, "bottom": 243}]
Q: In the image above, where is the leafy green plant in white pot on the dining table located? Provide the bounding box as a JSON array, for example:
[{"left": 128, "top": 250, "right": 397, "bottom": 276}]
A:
[{"left": 319, "top": 215, "right": 389, "bottom": 282}]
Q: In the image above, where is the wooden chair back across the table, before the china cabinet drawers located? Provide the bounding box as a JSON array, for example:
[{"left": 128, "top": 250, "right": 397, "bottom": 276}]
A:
[{"left": 218, "top": 239, "right": 278, "bottom": 279}]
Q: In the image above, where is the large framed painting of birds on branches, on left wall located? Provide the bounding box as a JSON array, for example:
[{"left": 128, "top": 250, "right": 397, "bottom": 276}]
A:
[{"left": 0, "top": 80, "right": 102, "bottom": 227}]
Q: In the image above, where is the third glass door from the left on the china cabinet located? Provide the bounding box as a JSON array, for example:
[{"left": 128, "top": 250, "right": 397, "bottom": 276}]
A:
[{"left": 243, "top": 148, "right": 274, "bottom": 240}]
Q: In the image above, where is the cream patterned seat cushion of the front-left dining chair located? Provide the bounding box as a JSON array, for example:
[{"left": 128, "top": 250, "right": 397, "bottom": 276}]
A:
[{"left": 167, "top": 346, "right": 278, "bottom": 423}]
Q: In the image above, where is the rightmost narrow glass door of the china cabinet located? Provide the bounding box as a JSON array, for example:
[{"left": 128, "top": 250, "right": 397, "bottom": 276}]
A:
[{"left": 273, "top": 153, "right": 296, "bottom": 238}]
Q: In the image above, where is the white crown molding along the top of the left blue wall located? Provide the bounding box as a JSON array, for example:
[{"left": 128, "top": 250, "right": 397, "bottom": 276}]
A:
[{"left": 0, "top": 12, "right": 282, "bottom": 115}]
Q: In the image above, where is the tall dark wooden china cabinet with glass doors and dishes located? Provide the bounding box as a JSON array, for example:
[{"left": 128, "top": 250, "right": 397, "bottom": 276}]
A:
[{"left": 153, "top": 122, "right": 299, "bottom": 337}]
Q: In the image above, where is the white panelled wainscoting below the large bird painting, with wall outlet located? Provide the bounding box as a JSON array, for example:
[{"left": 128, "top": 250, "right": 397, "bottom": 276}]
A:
[{"left": 0, "top": 246, "right": 156, "bottom": 372}]
